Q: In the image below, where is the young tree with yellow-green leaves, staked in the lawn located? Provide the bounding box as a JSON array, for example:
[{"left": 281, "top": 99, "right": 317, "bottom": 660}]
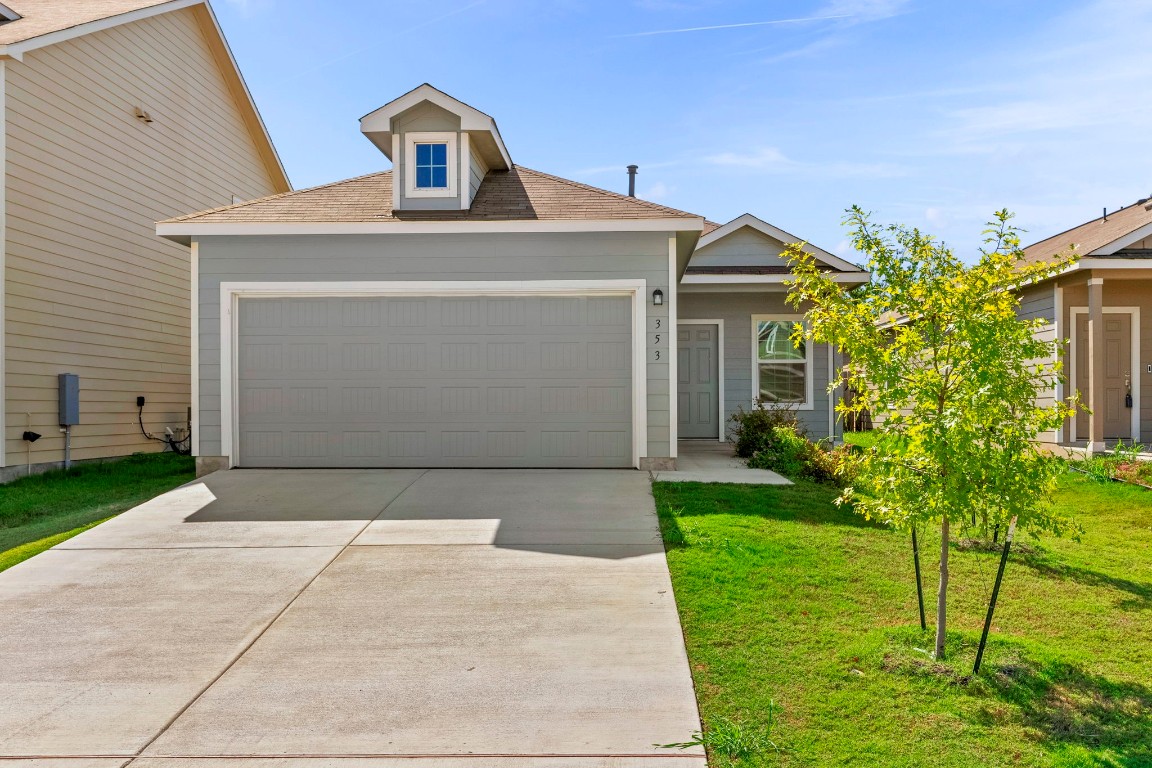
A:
[{"left": 786, "top": 207, "right": 1076, "bottom": 657}]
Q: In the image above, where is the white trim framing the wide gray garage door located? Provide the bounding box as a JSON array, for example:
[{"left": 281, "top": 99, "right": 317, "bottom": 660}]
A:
[{"left": 220, "top": 280, "right": 647, "bottom": 469}]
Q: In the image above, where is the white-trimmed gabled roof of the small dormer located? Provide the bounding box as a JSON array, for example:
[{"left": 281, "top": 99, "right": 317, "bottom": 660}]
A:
[{"left": 361, "top": 83, "right": 513, "bottom": 170}]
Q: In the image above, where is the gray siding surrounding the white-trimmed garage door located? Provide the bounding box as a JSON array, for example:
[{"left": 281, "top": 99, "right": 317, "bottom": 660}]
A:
[{"left": 198, "top": 233, "right": 672, "bottom": 457}]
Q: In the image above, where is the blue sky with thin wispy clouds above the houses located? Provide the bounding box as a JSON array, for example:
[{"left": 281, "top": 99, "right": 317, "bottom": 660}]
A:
[{"left": 214, "top": 0, "right": 1152, "bottom": 256}]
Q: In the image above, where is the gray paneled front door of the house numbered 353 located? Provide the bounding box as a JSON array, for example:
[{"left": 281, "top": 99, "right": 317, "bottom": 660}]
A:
[{"left": 677, "top": 324, "right": 720, "bottom": 440}]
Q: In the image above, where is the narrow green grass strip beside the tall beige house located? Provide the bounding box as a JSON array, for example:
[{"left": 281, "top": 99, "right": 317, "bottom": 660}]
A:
[{"left": 0, "top": 454, "right": 195, "bottom": 571}]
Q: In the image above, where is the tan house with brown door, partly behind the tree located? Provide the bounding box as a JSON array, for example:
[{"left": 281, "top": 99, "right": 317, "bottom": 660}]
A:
[{"left": 1021, "top": 199, "right": 1152, "bottom": 450}]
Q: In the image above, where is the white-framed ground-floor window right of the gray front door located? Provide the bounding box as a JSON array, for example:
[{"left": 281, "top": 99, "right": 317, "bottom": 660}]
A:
[{"left": 752, "top": 317, "right": 812, "bottom": 409}]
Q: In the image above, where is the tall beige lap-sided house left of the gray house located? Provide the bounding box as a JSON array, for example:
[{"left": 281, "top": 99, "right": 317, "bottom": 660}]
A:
[{"left": 0, "top": 0, "right": 290, "bottom": 479}]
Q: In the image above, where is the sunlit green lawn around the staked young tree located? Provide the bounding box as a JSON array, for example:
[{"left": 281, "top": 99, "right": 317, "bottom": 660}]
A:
[{"left": 654, "top": 474, "right": 1152, "bottom": 768}]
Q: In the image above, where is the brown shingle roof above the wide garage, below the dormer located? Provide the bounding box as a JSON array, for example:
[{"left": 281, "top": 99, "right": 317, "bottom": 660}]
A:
[{"left": 165, "top": 166, "right": 698, "bottom": 223}]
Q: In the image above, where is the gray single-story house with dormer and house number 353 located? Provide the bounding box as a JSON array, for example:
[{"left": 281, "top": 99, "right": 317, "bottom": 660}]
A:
[{"left": 157, "top": 85, "right": 867, "bottom": 471}]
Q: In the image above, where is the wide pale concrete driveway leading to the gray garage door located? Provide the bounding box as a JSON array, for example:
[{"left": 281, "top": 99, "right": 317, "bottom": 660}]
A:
[{"left": 0, "top": 470, "right": 705, "bottom": 768}]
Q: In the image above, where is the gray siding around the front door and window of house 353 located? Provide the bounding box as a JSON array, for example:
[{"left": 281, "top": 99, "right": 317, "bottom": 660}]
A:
[{"left": 677, "top": 292, "right": 834, "bottom": 438}]
